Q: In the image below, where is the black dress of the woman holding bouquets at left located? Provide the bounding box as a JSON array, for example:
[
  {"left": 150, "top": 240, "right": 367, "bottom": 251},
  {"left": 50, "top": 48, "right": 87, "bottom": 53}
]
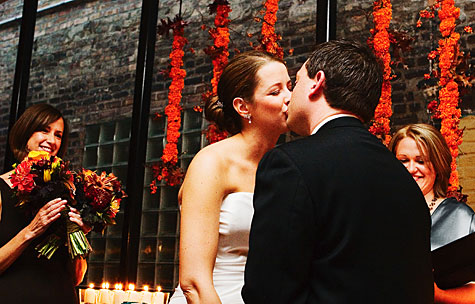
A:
[{"left": 0, "top": 178, "right": 78, "bottom": 304}]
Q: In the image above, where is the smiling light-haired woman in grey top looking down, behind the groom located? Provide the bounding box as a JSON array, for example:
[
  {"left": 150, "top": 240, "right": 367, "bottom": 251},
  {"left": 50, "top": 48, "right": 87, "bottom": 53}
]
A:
[{"left": 389, "top": 124, "right": 475, "bottom": 304}]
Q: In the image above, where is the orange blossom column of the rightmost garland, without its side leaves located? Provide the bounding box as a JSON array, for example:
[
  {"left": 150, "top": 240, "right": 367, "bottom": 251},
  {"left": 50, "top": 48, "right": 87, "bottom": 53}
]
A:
[{"left": 437, "top": 0, "right": 463, "bottom": 192}]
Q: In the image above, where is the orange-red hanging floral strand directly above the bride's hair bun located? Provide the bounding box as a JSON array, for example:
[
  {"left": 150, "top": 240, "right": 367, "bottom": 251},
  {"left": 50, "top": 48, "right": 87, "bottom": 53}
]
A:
[{"left": 203, "top": 0, "right": 231, "bottom": 144}]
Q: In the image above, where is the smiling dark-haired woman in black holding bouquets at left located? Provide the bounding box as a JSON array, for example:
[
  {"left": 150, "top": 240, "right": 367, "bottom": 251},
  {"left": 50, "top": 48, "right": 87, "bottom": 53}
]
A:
[{"left": 0, "top": 104, "right": 87, "bottom": 303}]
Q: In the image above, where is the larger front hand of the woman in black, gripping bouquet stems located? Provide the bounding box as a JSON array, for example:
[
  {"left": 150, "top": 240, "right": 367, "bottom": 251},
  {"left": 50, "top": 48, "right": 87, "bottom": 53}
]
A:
[{"left": 26, "top": 198, "right": 67, "bottom": 239}]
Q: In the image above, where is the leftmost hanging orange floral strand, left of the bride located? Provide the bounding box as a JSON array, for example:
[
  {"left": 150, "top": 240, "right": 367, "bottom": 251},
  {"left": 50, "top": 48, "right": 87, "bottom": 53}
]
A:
[{"left": 150, "top": 16, "right": 188, "bottom": 193}]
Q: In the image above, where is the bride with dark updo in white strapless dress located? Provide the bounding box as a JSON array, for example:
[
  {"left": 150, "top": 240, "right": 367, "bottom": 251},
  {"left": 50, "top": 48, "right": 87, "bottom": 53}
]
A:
[{"left": 170, "top": 51, "right": 291, "bottom": 304}]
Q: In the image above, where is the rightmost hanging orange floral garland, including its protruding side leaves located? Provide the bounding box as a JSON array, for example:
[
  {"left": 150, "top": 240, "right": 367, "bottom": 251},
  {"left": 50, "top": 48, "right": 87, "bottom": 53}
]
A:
[{"left": 417, "top": 0, "right": 473, "bottom": 197}]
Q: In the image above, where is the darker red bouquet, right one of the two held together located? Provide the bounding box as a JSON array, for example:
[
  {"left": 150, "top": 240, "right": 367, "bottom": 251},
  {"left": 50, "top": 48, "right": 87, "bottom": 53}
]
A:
[{"left": 74, "top": 169, "right": 126, "bottom": 232}]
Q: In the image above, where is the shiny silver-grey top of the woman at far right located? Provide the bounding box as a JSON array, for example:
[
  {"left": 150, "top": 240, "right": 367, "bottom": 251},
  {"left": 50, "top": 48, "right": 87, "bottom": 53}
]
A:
[{"left": 430, "top": 198, "right": 475, "bottom": 250}]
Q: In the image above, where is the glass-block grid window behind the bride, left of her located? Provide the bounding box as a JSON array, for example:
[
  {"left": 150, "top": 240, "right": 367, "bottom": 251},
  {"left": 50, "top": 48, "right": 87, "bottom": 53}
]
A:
[{"left": 83, "top": 109, "right": 206, "bottom": 291}]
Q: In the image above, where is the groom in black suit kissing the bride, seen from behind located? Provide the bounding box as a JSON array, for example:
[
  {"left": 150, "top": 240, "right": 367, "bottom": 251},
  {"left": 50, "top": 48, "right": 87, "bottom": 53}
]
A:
[{"left": 242, "top": 40, "right": 433, "bottom": 304}]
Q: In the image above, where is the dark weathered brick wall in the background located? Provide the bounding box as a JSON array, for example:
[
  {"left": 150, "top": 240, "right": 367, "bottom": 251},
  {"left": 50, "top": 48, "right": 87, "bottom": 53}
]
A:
[{"left": 0, "top": 0, "right": 475, "bottom": 192}]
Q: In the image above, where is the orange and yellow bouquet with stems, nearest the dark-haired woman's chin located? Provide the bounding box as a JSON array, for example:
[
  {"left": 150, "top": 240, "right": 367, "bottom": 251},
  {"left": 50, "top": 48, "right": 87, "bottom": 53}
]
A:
[{"left": 11, "top": 151, "right": 92, "bottom": 259}]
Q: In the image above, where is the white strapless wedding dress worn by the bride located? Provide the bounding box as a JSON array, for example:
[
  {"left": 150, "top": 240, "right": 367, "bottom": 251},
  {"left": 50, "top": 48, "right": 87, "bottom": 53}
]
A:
[{"left": 169, "top": 192, "right": 254, "bottom": 304}]
